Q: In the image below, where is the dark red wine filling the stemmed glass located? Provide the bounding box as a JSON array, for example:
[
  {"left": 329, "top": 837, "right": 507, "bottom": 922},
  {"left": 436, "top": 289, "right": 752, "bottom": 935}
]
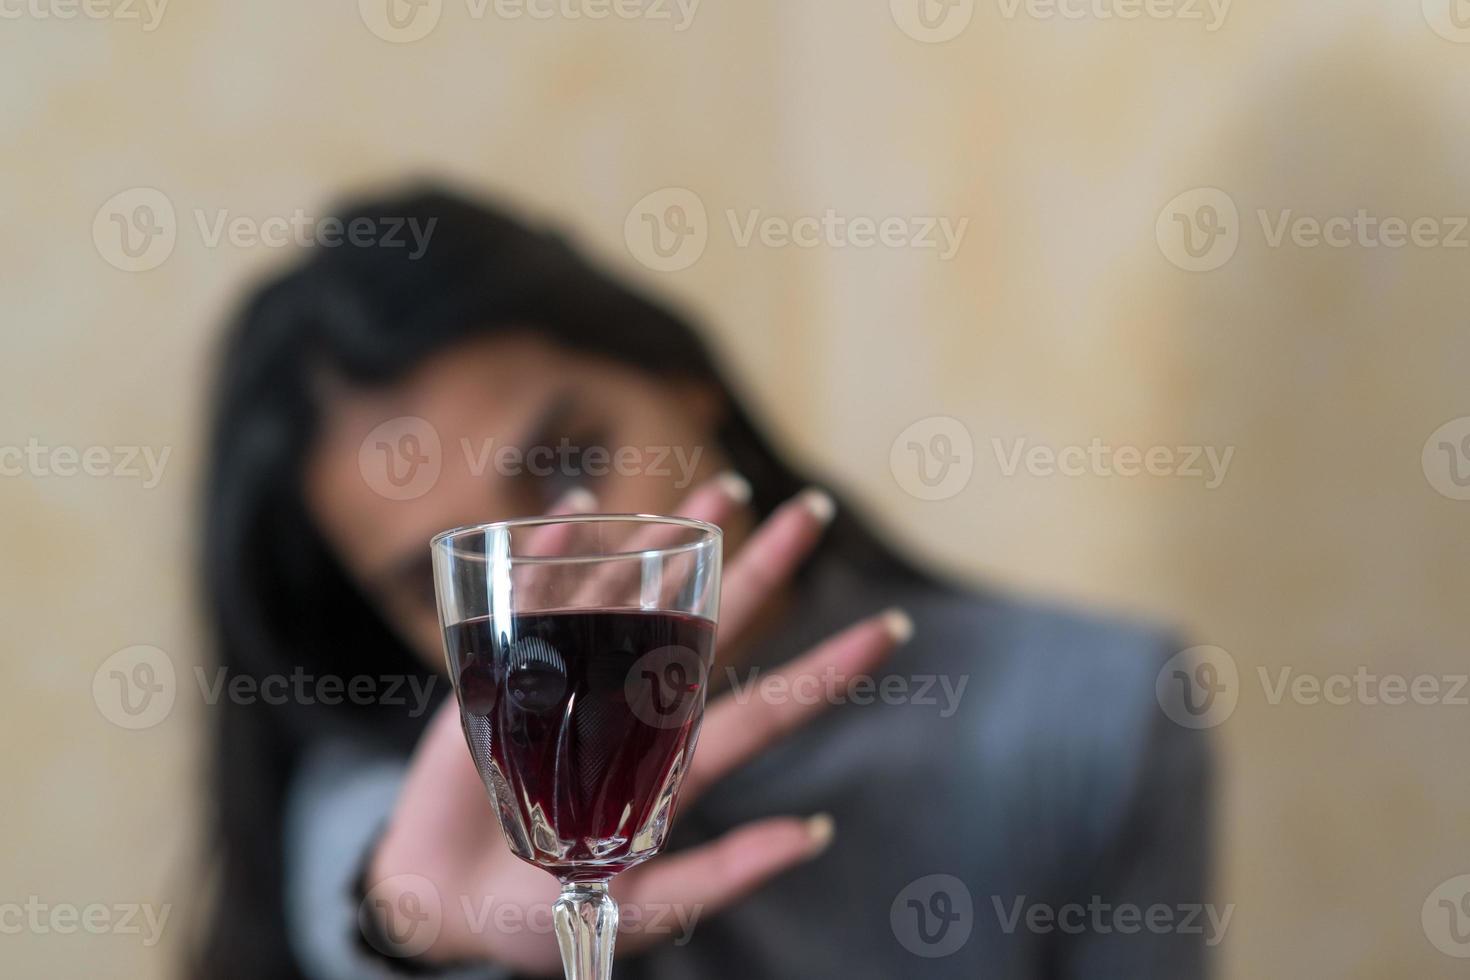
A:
[{"left": 444, "top": 610, "right": 714, "bottom": 882}]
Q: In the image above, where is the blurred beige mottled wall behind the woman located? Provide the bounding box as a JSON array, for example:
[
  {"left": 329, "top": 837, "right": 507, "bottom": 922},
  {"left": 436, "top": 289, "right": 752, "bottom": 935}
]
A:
[{"left": 0, "top": 0, "right": 1470, "bottom": 980}]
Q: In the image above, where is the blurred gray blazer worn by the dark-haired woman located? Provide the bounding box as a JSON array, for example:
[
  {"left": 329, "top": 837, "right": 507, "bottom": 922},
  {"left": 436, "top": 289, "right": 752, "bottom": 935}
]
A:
[{"left": 287, "top": 561, "right": 1232, "bottom": 980}]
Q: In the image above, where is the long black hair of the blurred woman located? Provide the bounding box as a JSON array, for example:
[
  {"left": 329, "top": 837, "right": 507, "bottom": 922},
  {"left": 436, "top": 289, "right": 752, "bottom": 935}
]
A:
[{"left": 194, "top": 187, "right": 916, "bottom": 980}]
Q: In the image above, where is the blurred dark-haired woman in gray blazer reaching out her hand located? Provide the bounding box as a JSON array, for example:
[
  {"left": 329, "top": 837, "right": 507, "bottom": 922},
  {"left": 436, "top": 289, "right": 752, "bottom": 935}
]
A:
[{"left": 197, "top": 190, "right": 1210, "bottom": 980}]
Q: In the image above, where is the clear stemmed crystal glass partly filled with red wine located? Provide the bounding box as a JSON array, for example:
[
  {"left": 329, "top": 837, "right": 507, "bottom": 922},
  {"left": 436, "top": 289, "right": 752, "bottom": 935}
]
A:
[{"left": 431, "top": 514, "right": 720, "bottom": 980}]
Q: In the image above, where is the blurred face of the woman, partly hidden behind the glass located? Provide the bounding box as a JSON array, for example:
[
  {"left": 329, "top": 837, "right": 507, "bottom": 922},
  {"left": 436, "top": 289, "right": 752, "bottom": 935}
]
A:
[{"left": 304, "top": 335, "right": 726, "bottom": 664}]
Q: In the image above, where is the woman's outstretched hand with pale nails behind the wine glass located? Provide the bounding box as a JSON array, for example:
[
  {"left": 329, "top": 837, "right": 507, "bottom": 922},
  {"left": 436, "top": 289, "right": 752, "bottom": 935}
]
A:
[{"left": 365, "top": 475, "right": 911, "bottom": 974}]
